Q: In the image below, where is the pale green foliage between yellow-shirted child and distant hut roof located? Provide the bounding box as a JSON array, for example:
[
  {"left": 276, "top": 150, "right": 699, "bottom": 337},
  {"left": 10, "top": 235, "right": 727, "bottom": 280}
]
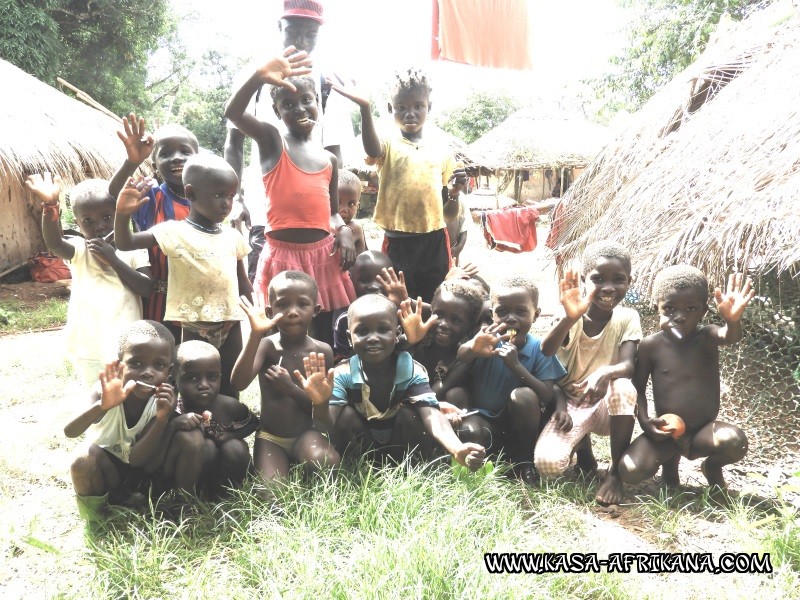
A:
[{"left": 437, "top": 92, "right": 519, "bottom": 144}]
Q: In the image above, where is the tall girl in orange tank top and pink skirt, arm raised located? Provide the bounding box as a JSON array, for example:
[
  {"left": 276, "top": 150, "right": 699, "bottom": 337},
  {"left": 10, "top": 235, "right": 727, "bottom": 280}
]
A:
[{"left": 225, "top": 46, "right": 356, "bottom": 344}]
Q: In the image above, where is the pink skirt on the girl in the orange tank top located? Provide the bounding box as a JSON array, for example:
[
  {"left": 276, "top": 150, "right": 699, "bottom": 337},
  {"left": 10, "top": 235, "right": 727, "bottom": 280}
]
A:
[{"left": 253, "top": 235, "right": 356, "bottom": 311}]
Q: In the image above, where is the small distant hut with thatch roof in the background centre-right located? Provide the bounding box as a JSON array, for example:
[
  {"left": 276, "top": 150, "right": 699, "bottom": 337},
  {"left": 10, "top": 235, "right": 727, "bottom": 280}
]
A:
[{"left": 469, "top": 108, "right": 609, "bottom": 202}]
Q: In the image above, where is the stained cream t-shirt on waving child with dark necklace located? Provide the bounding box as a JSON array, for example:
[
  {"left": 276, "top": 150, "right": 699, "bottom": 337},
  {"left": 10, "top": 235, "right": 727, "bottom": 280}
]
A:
[{"left": 150, "top": 221, "right": 250, "bottom": 323}]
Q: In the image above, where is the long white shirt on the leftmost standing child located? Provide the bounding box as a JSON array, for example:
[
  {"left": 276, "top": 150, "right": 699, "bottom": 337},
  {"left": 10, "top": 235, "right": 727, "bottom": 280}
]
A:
[{"left": 64, "top": 237, "right": 150, "bottom": 363}]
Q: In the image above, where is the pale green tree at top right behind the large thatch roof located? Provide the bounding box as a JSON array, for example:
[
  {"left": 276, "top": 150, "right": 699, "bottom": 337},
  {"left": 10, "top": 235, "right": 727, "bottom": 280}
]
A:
[{"left": 592, "top": 0, "right": 768, "bottom": 111}]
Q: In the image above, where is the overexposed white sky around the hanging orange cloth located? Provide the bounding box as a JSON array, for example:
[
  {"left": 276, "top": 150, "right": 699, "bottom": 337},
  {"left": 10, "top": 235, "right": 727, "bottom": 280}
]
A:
[{"left": 172, "top": 0, "right": 627, "bottom": 109}]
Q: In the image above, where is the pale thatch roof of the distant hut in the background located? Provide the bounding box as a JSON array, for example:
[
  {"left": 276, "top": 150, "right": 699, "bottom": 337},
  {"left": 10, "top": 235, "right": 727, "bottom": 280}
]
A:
[{"left": 469, "top": 108, "right": 609, "bottom": 170}]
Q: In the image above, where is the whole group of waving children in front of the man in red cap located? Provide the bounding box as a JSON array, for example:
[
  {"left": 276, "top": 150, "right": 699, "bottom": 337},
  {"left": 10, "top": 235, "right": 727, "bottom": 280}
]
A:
[{"left": 21, "top": 47, "right": 753, "bottom": 515}]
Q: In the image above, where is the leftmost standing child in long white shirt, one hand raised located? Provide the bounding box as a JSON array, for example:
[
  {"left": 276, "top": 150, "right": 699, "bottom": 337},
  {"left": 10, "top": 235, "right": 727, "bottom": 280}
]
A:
[{"left": 26, "top": 173, "right": 153, "bottom": 386}]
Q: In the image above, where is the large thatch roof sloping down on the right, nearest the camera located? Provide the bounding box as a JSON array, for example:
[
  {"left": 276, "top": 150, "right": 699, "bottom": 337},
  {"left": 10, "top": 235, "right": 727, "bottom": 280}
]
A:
[{"left": 550, "top": 5, "right": 800, "bottom": 286}]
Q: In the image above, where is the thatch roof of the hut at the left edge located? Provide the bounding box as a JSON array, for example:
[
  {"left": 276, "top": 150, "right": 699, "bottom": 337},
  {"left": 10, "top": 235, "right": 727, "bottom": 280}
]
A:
[{"left": 0, "top": 60, "right": 133, "bottom": 185}]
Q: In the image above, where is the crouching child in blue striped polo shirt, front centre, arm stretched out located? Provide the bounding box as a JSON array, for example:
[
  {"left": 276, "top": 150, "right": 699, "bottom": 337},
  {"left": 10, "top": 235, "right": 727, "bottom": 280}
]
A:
[{"left": 295, "top": 294, "right": 486, "bottom": 469}]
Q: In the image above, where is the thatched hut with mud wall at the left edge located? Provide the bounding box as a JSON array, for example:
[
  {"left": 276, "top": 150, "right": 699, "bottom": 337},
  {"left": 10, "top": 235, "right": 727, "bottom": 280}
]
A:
[{"left": 0, "top": 60, "right": 131, "bottom": 270}]
